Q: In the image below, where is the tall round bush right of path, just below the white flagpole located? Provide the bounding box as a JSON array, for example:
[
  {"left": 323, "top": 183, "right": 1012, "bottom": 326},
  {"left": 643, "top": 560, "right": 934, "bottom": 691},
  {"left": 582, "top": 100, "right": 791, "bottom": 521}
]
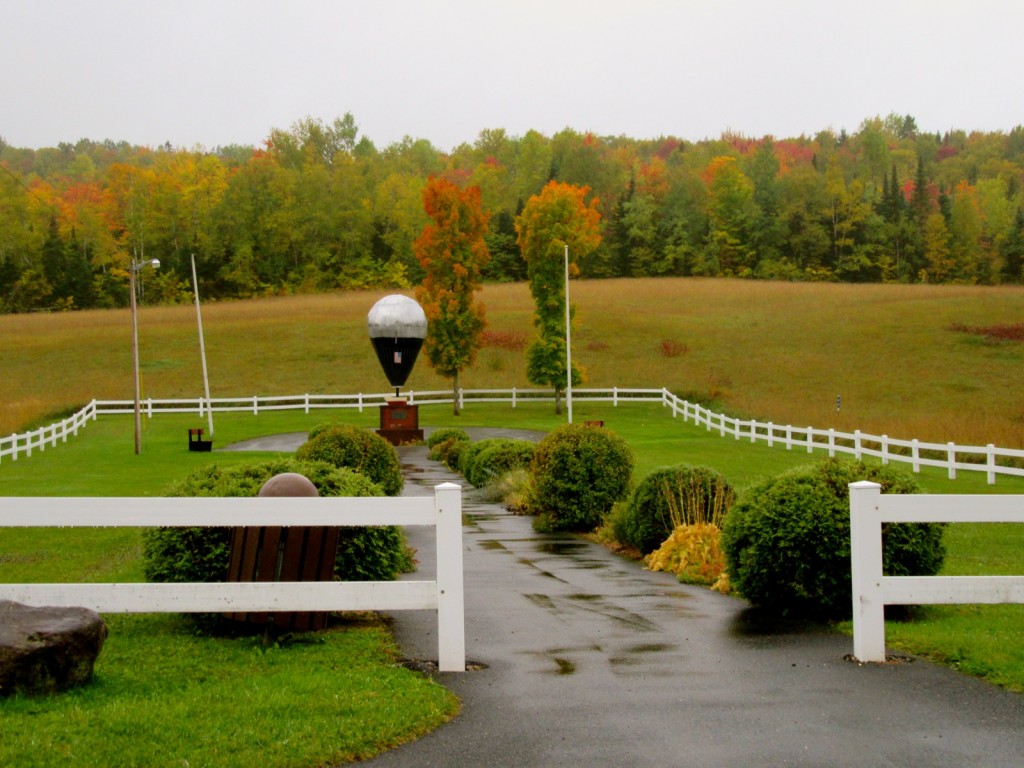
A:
[{"left": 528, "top": 424, "right": 635, "bottom": 531}]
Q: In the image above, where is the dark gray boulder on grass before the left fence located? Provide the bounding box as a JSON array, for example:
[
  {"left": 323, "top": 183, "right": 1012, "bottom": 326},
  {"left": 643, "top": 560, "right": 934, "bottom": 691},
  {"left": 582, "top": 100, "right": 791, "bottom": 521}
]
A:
[{"left": 0, "top": 600, "right": 106, "bottom": 696}]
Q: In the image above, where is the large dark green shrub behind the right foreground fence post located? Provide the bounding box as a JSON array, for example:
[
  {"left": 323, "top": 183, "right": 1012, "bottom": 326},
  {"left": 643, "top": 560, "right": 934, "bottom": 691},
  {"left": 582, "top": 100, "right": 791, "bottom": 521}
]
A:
[{"left": 722, "top": 459, "right": 945, "bottom": 618}]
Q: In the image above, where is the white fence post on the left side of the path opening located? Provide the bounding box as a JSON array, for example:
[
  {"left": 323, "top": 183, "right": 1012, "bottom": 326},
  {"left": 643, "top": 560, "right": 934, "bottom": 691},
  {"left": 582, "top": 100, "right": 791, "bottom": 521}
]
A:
[{"left": 434, "top": 482, "right": 466, "bottom": 672}]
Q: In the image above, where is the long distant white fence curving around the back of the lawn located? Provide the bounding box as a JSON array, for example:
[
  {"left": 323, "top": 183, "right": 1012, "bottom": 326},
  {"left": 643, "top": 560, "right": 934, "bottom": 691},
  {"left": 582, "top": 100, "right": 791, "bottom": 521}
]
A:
[{"left": 0, "top": 387, "right": 1024, "bottom": 484}]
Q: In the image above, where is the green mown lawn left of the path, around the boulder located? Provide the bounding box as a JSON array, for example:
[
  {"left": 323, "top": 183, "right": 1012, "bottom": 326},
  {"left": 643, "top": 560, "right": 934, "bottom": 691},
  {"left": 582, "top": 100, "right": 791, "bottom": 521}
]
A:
[{"left": 0, "top": 414, "right": 459, "bottom": 768}]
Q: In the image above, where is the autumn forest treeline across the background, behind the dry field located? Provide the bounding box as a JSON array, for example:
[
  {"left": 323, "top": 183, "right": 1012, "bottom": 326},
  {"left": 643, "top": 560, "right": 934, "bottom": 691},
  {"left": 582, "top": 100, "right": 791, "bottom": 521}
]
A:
[{"left": 0, "top": 114, "right": 1024, "bottom": 312}]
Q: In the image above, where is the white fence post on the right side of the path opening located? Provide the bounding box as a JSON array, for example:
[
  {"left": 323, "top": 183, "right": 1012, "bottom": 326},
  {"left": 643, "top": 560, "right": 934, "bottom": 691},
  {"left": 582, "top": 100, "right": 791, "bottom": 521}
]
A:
[{"left": 850, "top": 480, "right": 886, "bottom": 662}]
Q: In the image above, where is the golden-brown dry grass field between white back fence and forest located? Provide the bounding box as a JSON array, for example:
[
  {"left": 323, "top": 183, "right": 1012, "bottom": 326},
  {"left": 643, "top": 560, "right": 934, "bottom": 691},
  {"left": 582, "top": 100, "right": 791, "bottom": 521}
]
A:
[{"left": 0, "top": 279, "right": 1024, "bottom": 447}]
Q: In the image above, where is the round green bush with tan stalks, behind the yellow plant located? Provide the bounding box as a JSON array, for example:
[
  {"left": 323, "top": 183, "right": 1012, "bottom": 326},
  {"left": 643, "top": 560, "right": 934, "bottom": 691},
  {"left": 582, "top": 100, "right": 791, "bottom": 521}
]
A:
[{"left": 610, "top": 464, "right": 735, "bottom": 555}]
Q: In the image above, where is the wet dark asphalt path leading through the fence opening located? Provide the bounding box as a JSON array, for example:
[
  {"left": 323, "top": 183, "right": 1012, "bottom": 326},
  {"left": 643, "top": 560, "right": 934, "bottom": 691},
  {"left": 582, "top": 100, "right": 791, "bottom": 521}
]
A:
[{"left": 370, "top": 447, "right": 1024, "bottom": 768}]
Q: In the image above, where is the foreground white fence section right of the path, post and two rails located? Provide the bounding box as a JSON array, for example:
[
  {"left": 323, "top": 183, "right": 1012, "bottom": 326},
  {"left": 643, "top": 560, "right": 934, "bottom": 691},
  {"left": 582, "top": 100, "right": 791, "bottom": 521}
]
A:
[{"left": 850, "top": 480, "right": 1024, "bottom": 662}]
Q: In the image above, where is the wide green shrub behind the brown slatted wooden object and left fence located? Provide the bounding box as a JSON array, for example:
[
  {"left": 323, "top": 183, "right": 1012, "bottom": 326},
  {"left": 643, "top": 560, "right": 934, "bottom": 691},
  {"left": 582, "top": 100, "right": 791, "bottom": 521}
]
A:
[{"left": 142, "top": 459, "right": 413, "bottom": 583}]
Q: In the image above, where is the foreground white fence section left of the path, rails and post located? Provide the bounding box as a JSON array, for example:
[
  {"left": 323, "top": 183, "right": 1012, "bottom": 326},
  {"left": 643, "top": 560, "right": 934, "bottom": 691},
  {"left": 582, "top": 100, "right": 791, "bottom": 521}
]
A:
[{"left": 0, "top": 483, "right": 466, "bottom": 672}]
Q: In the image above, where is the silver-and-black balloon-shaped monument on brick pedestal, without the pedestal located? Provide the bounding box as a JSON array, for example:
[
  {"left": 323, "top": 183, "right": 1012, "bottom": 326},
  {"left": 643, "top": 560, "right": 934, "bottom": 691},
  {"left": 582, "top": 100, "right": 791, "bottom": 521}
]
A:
[{"left": 367, "top": 294, "right": 427, "bottom": 395}]
